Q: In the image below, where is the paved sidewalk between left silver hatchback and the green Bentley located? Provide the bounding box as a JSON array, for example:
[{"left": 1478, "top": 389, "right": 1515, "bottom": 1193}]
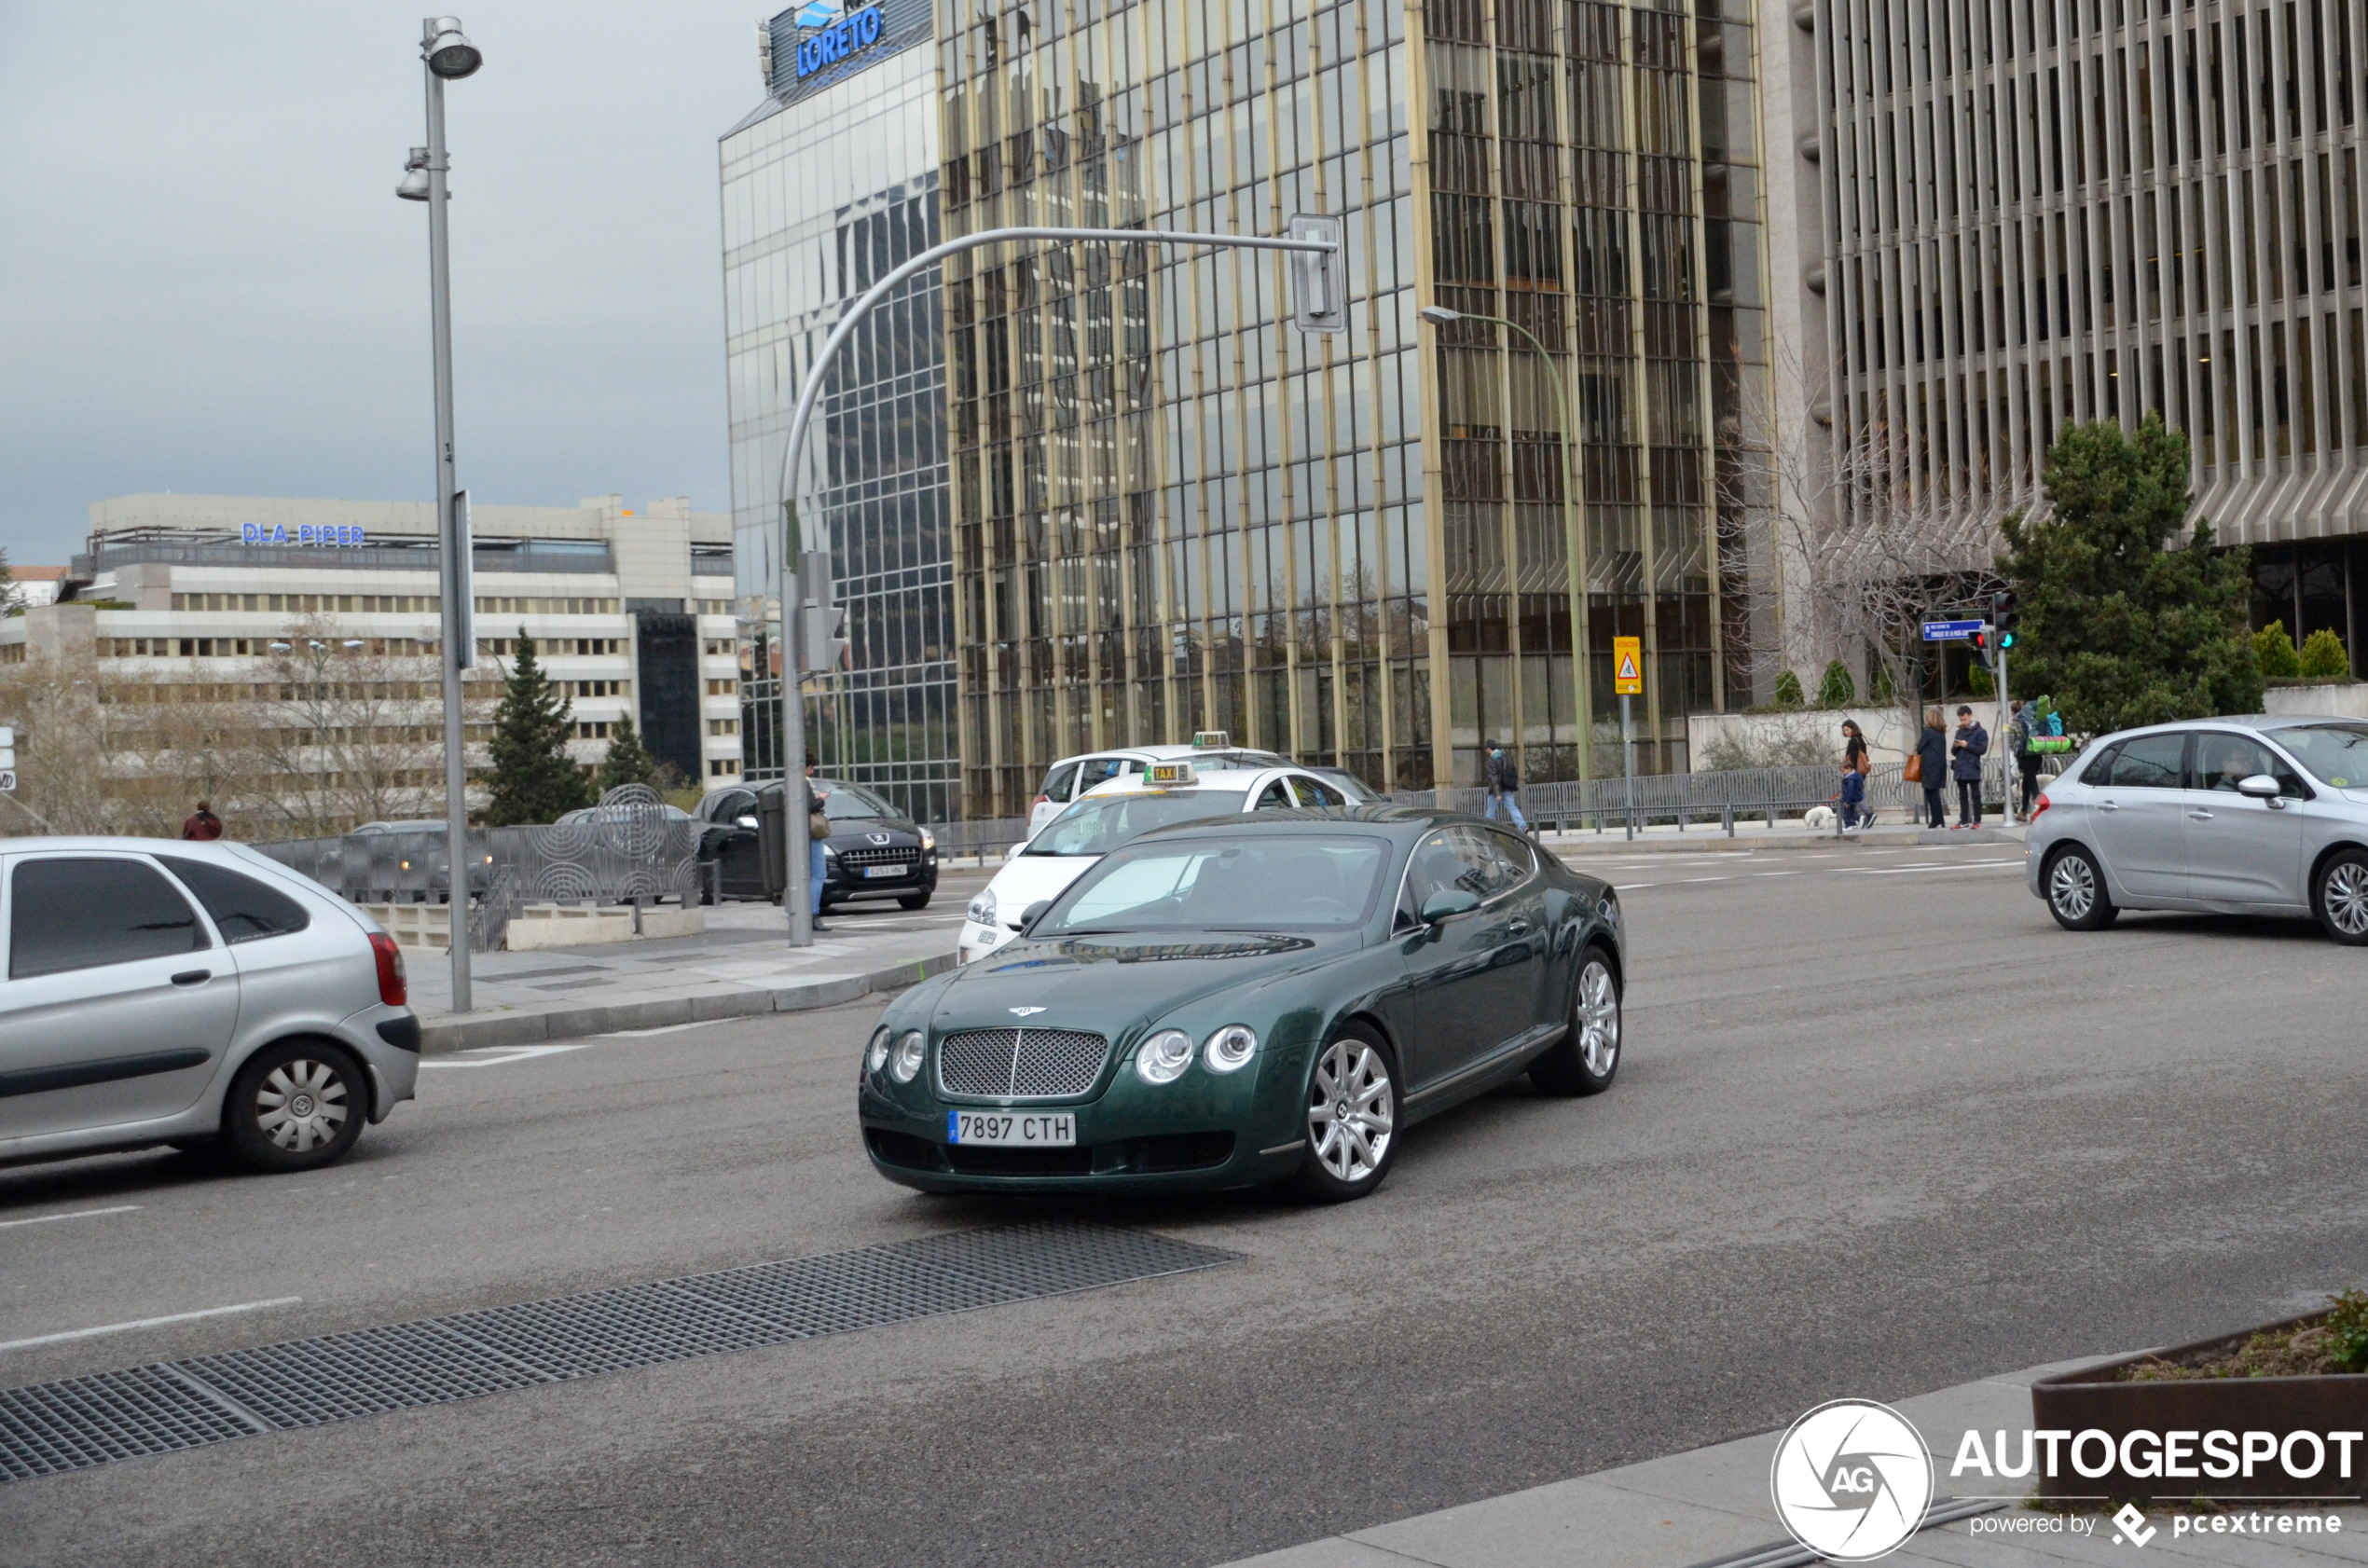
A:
[{"left": 405, "top": 895, "right": 983, "bottom": 1056}]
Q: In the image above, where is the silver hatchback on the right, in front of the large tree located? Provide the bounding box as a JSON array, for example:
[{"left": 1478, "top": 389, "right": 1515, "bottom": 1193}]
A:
[{"left": 2025, "top": 715, "right": 2368, "bottom": 945}]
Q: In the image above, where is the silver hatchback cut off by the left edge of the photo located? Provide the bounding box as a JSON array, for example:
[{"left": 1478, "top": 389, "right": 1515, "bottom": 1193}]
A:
[{"left": 0, "top": 838, "right": 420, "bottom": 1170}]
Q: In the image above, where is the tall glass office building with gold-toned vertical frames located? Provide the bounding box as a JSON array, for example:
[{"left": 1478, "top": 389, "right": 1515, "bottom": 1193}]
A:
[{"left": 938, "top": 0, "right": 1767, "bottom": 815}]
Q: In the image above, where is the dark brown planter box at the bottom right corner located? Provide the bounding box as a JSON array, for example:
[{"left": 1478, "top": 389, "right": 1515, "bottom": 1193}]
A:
[{"left": 2031, "top": 1313, "right": 2368, "bottom": 1502}]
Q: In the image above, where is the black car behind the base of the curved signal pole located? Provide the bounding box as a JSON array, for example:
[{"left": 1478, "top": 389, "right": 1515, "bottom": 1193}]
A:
[{"left": 696, "top": 779, "right": 938, "bottom": 910}]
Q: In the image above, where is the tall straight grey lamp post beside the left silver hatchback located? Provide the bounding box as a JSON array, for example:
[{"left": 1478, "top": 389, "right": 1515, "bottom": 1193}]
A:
[{"left": 395, "top": 17, "right": 486, "bottom": 1013}]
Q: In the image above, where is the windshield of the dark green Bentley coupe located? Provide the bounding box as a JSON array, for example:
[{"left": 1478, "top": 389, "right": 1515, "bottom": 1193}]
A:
[{"left": 1027, "top": 833, "right": 1390, "bottom": 938}]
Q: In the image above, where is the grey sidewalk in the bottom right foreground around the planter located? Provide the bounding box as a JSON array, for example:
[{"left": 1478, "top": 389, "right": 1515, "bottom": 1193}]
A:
[{"left": 1232, "top": 1355, "right": 2368, "bottom": 1568}]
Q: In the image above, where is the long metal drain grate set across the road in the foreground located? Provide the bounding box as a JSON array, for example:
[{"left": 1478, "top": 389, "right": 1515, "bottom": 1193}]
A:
[{"left": 0, "top": 1220, "right": 1241, "bottom": 1480}]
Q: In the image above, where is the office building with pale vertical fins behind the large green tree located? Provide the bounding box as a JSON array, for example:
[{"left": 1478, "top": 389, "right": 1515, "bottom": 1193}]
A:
[{"left": 1795, "top": 0, "right": 2368, "bottom": 668}]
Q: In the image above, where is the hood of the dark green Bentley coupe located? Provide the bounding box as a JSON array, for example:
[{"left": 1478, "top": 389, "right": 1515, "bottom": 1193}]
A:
[{"left": 930, "top": 931, "right": 1364, "bottom": 1039}]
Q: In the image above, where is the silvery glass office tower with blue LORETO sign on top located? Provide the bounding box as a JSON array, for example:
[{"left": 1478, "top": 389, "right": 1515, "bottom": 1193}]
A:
[{"left": 723, "top": 0, "right": 961, "bottom": 822}]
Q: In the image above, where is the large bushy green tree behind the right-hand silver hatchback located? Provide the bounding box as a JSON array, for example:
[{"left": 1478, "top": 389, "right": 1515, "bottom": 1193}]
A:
[{"left": 2001, "top": 415, "right": 2262, "bottom": 735}]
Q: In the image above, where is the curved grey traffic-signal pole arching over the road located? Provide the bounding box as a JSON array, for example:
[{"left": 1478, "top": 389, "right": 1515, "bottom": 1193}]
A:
[{"left": 781, "top": 218, "right": 1347, "bottom": 947}]
